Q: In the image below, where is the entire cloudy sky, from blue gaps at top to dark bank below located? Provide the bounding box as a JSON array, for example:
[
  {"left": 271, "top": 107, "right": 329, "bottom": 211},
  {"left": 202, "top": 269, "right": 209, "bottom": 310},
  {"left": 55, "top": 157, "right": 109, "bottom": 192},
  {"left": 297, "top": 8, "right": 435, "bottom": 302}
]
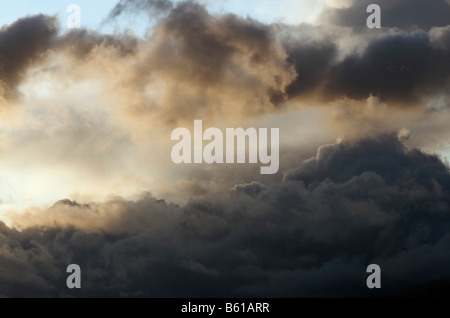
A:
[{"left": 0, "top": 0, "right": 450, "bottom": 298}]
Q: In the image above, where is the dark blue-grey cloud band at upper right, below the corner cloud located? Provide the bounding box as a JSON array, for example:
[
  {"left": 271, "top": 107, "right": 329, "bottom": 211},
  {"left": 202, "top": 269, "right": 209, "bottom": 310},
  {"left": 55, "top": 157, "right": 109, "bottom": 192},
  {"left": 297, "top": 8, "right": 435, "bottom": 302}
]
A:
[{"left": 283, "top": 27, "right": 450, "bottom": 103}]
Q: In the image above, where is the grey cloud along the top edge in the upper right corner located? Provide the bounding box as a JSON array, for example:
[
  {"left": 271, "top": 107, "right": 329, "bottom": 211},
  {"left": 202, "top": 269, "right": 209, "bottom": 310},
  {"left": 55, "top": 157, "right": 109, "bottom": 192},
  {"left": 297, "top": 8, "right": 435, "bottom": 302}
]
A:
[{"left": 319, "top": 0, "right": 450, "bottom": 30}]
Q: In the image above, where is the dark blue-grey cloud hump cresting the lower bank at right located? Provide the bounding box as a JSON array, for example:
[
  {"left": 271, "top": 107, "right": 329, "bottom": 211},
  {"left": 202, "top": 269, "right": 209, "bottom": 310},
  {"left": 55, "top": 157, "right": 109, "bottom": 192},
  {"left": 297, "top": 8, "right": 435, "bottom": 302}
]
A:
[{"left": 285, "top": 135, "right": 450, "bottom": 192}]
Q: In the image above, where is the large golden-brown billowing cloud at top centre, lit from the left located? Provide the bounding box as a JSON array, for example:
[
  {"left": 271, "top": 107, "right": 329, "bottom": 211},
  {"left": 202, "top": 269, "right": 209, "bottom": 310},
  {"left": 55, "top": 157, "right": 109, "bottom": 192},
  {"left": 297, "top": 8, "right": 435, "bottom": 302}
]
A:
[{"left": 125, "top": 2, "right": 296, "bottom": 122}]
